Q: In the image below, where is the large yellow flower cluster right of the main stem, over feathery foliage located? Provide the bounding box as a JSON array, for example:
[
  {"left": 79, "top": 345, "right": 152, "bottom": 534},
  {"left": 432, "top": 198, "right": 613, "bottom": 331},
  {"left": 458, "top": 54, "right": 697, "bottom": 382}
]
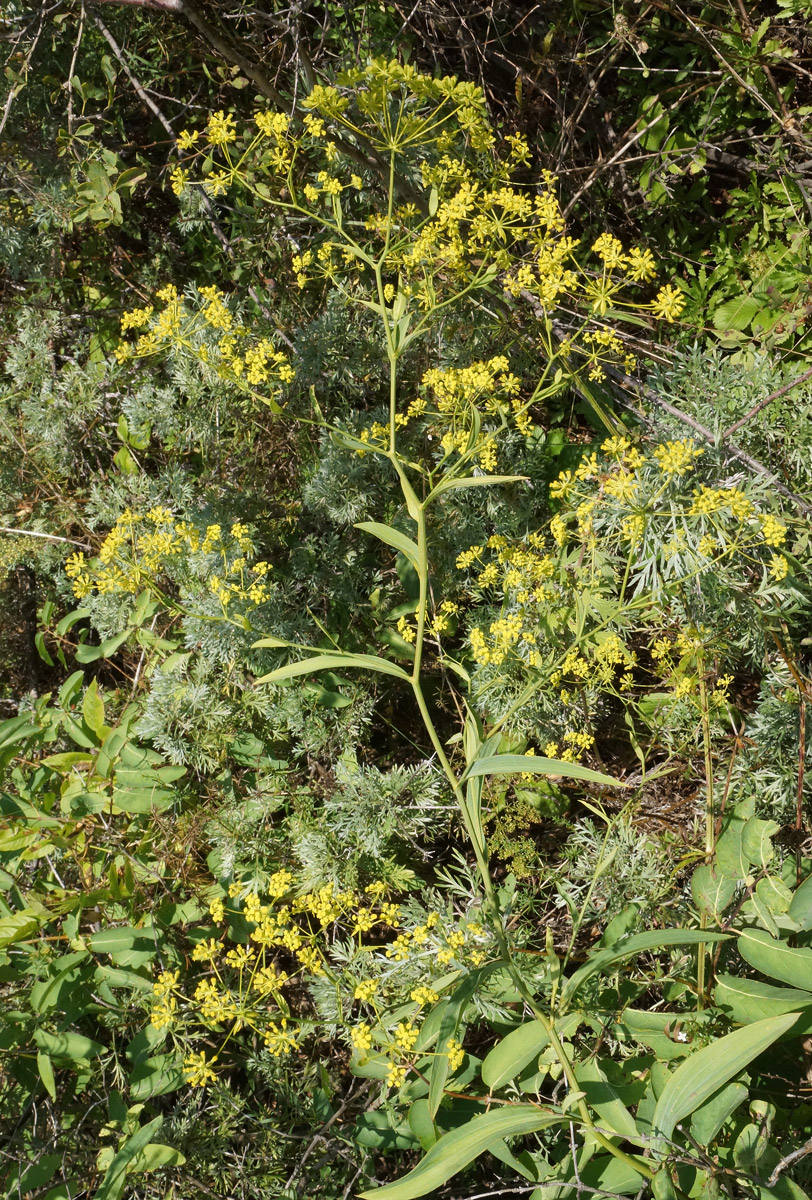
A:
[{"left": 457, "top": 432, "right": 792, "bottom": 729}]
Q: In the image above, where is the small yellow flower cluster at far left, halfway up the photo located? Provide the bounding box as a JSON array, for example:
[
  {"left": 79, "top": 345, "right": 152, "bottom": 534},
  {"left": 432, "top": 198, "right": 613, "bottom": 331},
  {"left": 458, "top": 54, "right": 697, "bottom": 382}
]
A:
[{"left": 65, "top": 506, "right": 271, "bottom": 611}]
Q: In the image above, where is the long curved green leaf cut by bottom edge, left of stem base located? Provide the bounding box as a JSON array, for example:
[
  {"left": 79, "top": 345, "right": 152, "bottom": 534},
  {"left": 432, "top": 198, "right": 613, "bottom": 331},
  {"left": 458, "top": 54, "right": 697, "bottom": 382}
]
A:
[{"left": 360, "top": 1104, "right": 560, "bottom": 1200}]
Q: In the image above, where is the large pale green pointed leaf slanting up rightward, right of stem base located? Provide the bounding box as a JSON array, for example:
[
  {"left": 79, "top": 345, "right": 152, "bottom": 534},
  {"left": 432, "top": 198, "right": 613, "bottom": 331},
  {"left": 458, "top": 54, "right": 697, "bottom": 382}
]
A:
[{"left": 652, "top": 1013, "right": 798, "bottom": 1153}]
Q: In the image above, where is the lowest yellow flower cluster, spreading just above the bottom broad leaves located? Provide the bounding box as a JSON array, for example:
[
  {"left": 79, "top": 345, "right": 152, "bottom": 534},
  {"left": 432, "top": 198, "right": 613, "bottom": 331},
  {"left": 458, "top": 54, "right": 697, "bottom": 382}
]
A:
[{"left": 150, "top": 870, "right": 491, "bottom": 1087}]
